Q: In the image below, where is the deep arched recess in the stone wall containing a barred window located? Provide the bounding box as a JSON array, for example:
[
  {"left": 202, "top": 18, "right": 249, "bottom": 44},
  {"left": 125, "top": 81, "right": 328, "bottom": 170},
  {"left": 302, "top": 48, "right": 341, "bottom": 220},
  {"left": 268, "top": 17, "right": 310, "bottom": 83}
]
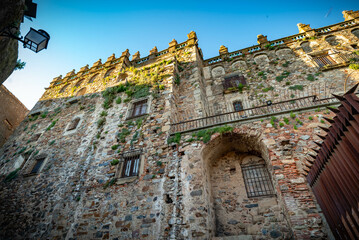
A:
[{"left": 201, "top": 129, "right": 288, "bottom": 237}]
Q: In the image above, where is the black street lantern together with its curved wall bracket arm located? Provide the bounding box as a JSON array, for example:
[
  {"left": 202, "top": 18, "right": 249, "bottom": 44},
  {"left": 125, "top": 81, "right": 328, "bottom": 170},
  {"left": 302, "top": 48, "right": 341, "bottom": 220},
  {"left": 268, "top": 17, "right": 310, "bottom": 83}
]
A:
[{"left": 0, "top": 26, "right": 50, "bottom": 53}]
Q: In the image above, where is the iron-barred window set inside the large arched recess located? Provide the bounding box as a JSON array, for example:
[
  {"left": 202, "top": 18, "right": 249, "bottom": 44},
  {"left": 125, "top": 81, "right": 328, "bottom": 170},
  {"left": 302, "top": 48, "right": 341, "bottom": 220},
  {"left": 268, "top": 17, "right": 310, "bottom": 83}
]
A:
[{"left": 241, "top": 164, "right": 274, "bottom": 197}]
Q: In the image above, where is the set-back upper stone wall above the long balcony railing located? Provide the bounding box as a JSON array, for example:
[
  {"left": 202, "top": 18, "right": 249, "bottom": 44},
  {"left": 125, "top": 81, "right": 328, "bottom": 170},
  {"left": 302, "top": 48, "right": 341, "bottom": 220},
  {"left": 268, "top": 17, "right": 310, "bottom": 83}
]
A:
[{"left": 203, "top": 24, "right": 359, "bottom": 113}]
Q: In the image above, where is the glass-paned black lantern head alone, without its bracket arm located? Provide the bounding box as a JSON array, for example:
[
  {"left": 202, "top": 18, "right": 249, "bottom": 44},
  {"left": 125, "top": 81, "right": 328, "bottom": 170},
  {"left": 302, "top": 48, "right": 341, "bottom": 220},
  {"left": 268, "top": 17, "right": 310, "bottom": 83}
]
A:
[{"left": 23, "top": 28, "right": 50, "bottom": 53}]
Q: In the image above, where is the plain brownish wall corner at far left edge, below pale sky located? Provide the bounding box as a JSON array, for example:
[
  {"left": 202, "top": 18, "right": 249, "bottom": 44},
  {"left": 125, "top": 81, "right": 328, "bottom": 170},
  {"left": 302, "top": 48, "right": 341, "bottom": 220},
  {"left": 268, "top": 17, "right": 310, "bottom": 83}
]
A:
[{"left": 0, "top": 85, "right": 29, "bottom": 147}]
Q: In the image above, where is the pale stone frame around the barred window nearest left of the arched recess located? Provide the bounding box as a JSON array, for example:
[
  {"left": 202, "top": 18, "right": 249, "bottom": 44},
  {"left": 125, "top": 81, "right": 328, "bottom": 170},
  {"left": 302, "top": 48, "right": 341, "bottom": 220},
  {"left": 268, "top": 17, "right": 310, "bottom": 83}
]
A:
[{"left": 115, "top": 149, "right": 145, "bottom": 184}]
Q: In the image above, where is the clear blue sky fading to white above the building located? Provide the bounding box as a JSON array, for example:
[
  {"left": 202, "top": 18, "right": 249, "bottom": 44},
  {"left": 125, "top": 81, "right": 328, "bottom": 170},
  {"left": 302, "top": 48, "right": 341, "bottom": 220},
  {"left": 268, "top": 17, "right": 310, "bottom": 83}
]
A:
[{"left": 4, "top": 0, "right": 359, "bottom": 109}]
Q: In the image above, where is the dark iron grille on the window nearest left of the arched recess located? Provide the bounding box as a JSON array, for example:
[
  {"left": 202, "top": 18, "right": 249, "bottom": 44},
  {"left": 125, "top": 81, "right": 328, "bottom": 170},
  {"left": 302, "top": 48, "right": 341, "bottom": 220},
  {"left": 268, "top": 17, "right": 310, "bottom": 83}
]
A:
[{"left": 121, "top": 150, "right": 141, "bottom": 178}]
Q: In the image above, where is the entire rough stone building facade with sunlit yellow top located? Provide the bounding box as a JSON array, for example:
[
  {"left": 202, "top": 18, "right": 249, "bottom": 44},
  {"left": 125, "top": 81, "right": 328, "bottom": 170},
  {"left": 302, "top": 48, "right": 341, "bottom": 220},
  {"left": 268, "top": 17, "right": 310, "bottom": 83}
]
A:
[{"left": 0, "top": 14, "right": 359, "bottom": 239}]
